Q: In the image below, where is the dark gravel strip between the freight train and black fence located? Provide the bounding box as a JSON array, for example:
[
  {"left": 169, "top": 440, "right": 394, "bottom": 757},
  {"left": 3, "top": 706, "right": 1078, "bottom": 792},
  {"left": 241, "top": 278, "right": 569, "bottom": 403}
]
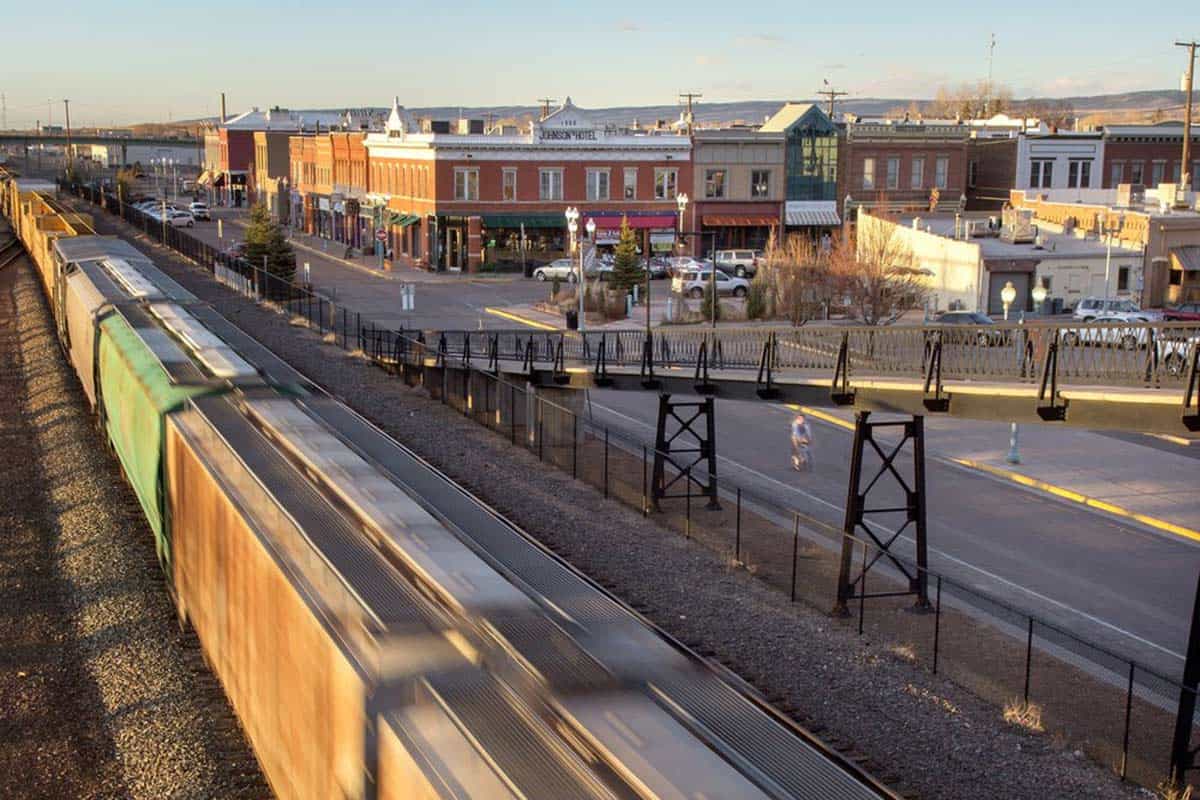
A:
[{"left": 72, "top": 203, "right": 1146, "bottom": 800}]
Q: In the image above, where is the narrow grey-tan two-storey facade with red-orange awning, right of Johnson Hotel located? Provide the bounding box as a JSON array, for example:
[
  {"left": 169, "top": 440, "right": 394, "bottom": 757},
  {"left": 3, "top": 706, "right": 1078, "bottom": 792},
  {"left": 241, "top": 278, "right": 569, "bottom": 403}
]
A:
[{"left": 689, "top": 128, "right": 785, "bottom": 252}]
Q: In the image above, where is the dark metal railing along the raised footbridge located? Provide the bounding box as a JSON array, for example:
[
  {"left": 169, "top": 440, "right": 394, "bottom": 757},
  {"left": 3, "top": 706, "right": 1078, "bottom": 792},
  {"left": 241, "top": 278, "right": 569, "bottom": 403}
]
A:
[{"left": 426, "top": 321, "right": 1200, "bottom": 386}]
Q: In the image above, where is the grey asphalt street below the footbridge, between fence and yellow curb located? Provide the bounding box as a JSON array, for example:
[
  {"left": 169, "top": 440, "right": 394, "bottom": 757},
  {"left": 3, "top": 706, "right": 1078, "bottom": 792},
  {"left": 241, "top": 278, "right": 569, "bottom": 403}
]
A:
[{"left": 593, "top": 391, "right": 1200, "bottom": 675}]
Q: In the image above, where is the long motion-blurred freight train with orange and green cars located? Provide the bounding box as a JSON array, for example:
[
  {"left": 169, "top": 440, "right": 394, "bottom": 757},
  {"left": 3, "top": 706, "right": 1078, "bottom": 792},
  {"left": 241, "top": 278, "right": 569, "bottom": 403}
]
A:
[{"left": 0, "top": 173, "right": 894, "bottom": 800}]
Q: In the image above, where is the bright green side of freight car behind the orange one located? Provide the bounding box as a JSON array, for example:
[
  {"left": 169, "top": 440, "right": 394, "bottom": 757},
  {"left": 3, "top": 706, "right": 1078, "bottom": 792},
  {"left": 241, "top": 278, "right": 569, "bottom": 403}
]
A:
[{"left": 98, "top": 314, "right": 227, "bottom": 568}]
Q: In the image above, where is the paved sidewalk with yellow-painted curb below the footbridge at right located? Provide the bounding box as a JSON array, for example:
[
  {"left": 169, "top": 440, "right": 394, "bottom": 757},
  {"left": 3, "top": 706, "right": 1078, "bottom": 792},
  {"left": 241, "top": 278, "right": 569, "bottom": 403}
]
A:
[{"left": 797, "top": 407, "right": 1200, "bottom": 542}]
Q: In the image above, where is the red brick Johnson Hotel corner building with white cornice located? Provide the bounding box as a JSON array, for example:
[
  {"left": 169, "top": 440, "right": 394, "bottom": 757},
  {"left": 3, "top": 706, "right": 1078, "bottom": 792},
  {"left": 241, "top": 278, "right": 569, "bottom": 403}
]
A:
[{"left": 365, "top": 98, "right": 695, "bottom": 270}]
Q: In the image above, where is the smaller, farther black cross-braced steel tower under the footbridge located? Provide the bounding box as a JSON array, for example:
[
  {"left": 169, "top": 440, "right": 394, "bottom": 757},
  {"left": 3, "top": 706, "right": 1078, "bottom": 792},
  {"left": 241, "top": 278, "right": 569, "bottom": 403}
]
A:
[{"left": 650, "top": 395, "right": 721, "bottom": 510}]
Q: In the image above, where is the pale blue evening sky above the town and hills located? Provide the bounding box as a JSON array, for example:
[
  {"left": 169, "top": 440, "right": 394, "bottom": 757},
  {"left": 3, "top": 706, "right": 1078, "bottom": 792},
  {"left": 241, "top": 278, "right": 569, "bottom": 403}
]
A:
[{"left": 0, "top": 0, "right": 1200, "bottom": 127}]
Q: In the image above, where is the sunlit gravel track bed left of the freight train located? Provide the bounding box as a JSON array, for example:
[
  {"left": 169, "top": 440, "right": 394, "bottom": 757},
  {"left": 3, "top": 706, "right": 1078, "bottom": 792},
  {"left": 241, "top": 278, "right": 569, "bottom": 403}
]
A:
[{"left": 0, "top": 255, "right": 270, "bottom": 800}]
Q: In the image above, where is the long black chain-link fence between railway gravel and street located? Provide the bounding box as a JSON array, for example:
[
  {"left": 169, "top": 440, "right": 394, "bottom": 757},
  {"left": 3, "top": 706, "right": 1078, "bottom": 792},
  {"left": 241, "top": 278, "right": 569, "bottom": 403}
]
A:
[{"left": 65, "top": 186, "right": 1190, "bottom": 786}]
